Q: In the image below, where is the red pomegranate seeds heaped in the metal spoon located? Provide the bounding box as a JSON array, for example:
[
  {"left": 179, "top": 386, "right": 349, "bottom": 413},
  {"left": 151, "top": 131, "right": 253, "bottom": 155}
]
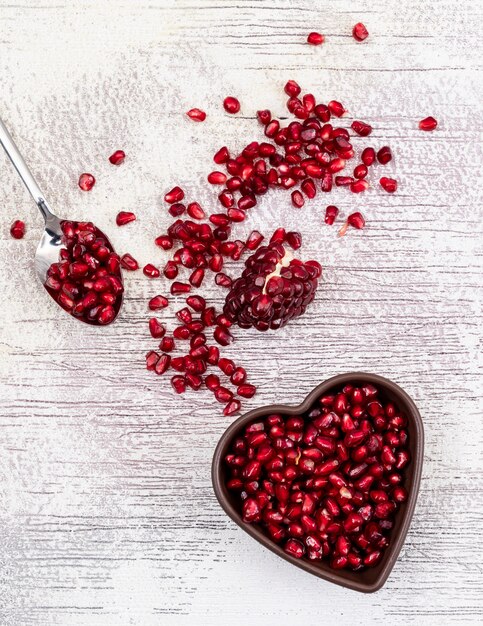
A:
[{"left": 45, "top": 221, "right": 124, "bottom": 325}]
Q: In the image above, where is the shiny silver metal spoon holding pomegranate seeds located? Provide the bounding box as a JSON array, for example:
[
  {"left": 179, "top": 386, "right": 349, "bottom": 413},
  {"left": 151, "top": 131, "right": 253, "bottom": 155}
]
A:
[{"left": 0, "top": 114, "right": 122, "bottom": 324}]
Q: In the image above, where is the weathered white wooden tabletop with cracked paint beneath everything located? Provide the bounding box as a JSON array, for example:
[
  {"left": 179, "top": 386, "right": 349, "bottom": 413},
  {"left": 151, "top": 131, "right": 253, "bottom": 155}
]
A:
[{"left": 0, "top": 0, "right": 483, "bottom": 626}]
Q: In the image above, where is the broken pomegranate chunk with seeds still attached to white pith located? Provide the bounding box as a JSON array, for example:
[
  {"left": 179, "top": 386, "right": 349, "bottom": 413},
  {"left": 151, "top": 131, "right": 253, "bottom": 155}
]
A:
[{"left": 223, "top": 238, "right": 322, "bottom": 330}]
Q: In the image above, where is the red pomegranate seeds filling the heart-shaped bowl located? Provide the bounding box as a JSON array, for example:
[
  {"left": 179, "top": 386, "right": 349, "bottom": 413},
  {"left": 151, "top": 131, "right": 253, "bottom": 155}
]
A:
[{"left": 225, "top": 384, "right": 410, "bottom": 571}]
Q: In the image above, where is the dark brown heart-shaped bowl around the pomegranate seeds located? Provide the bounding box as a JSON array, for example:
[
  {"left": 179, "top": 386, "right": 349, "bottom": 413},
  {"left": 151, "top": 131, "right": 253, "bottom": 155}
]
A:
[{"left": 212, "top": 372, "right": 424, "bottom": 593}]
